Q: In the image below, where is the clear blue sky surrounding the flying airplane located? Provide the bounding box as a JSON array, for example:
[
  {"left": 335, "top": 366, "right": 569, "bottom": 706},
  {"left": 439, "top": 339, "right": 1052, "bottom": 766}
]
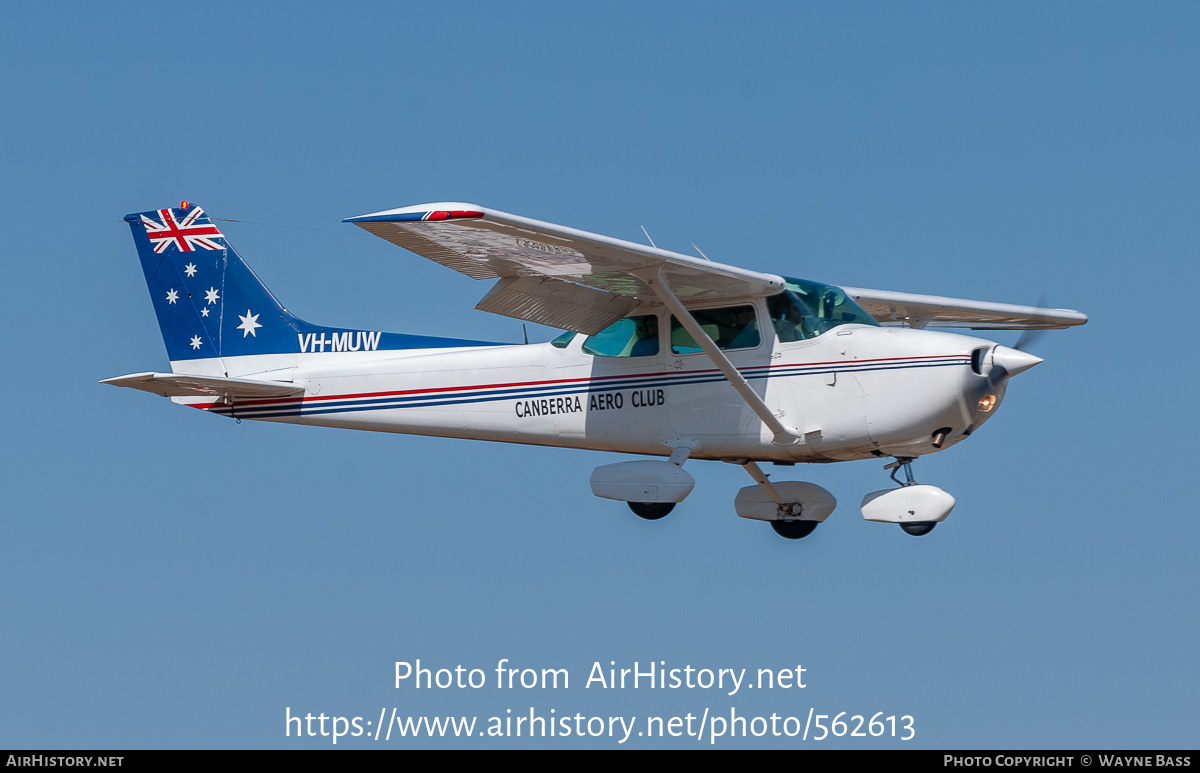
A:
[{"left": 0, "top": 2, "right": 1200, "bottom": 749}]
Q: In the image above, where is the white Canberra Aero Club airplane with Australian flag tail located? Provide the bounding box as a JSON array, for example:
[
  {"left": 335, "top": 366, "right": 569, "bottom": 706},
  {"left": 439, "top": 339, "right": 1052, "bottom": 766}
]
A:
[{"left": 103, "top": 202, "right": 1087, "bottom": 539}]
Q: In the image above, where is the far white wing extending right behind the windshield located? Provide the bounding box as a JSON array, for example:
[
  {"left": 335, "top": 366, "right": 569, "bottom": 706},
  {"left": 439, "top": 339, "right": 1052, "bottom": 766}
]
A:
[{"left": 842, "top": 287, "right": 1087, "bottom": 330}]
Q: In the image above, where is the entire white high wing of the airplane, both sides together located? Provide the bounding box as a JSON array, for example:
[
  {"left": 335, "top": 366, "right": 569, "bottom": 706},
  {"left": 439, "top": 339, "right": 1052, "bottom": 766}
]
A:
[{"left": 346, "top": 202, "right": 1087, "bottom": 335}]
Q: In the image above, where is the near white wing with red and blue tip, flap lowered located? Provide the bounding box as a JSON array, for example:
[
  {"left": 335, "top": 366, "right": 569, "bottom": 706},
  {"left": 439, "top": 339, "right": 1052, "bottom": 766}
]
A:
[{"left": 344, "top": 202, "right": 784, "bottom": 335}]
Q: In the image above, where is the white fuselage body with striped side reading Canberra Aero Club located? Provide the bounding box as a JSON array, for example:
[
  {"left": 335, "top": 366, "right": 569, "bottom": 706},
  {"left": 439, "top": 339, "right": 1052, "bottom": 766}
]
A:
[{"left": 176, "top": 324, "right": 1003, "bottom": 462}]
